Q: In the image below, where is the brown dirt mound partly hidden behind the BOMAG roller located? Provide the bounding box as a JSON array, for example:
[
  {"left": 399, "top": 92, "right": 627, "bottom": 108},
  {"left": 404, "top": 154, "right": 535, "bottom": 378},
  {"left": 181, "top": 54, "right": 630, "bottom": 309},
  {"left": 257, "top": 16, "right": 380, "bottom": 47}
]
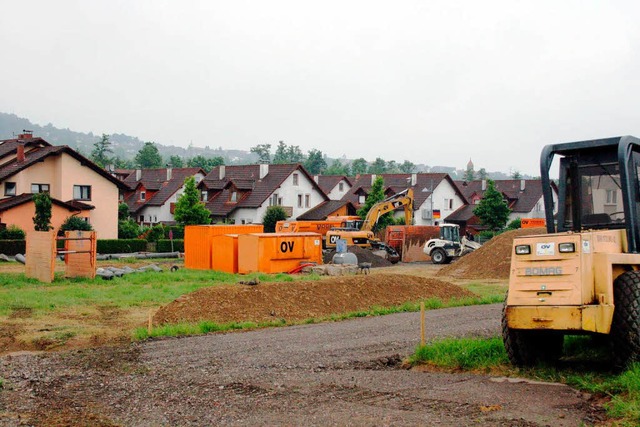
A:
[{"left": 440, "top": 228, "right": 546, "bottom": 279}]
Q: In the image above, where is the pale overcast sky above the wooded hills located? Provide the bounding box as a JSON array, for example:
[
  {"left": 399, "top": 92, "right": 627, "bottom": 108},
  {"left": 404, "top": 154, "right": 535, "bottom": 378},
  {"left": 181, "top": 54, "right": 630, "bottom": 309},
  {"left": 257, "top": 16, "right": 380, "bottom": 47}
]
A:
[{"left": 0, "top": 0, "right": 640, "bottom": 175}]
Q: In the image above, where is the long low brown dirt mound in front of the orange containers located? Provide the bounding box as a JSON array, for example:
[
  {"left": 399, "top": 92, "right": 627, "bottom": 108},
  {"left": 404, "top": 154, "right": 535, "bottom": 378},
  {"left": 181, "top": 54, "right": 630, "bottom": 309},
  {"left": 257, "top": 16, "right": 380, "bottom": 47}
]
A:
[{"left": 154, "top": 274, "right": 474, "bottom": 325}]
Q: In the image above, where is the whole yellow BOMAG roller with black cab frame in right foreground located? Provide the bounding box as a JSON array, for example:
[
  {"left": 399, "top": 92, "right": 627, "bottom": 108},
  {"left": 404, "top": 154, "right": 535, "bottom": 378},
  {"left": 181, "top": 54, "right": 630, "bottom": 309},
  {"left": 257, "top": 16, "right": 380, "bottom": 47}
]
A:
[{"left": 502, "top": 136, "right": 640, "bottom": 367}]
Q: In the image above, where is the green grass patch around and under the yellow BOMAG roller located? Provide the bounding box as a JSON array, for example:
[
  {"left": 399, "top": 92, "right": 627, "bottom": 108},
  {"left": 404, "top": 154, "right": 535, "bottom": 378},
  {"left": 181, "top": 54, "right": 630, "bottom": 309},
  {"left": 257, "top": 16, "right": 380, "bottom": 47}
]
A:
[{"left": 409, "top": 336, "right": 640, "bottom": 426}]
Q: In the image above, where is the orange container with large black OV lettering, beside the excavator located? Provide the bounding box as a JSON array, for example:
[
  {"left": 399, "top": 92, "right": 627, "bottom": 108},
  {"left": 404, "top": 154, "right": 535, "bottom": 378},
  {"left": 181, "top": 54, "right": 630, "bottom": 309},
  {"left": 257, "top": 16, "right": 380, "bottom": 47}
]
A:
[{"left": 238, "top": 233, "right": 322, "bottom": 274}]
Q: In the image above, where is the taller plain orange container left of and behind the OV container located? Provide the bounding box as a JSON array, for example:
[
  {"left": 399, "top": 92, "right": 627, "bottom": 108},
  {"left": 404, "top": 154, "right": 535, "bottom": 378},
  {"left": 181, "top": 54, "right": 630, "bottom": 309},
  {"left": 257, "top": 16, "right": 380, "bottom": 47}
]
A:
[{"left": 184, "top": 224, "right": 264, "bottom": 270}]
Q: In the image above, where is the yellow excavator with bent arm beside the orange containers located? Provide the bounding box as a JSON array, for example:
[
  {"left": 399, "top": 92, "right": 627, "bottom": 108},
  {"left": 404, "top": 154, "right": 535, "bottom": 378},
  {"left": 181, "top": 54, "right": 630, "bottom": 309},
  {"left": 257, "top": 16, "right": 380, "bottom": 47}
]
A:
[{"left": 326, "top": 188, "right": 413, "bottom": 262}]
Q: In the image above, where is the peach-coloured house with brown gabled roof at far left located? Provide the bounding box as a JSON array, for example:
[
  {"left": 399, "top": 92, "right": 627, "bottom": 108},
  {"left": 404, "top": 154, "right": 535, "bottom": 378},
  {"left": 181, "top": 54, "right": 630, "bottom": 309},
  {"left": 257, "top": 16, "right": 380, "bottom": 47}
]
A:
[{"left": 0, "top": 133, "right": 125, "bottom": 239}]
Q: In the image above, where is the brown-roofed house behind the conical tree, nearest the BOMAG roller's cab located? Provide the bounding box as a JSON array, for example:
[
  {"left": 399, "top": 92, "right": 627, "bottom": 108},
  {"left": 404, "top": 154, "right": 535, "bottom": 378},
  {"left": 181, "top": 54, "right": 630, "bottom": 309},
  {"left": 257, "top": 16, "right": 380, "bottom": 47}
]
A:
[{"left": 449, "top": 179, "right": 558, "bottom": 231}]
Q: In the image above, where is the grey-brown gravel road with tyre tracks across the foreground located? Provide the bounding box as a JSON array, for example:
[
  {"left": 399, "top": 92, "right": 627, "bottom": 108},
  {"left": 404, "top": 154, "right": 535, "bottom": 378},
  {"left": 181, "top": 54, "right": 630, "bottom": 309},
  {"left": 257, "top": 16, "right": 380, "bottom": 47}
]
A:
[{"left": 0, "top": 305, "right": 600, "bottom": 426}]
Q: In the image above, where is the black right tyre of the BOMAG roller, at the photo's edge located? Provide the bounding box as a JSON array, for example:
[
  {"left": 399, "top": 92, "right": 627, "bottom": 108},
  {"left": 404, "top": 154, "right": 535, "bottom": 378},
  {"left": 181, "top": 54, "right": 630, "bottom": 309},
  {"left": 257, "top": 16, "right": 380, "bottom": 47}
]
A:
[{"left": 611, "top": 271, "right": 640, "bottom": 369}]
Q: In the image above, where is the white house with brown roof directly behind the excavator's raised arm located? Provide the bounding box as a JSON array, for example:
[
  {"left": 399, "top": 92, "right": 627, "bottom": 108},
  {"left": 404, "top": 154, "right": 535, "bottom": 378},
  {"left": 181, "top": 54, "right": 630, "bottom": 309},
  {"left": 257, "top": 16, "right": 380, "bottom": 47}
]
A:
[{"left": 342, "top": 173, "right": 467, "bottom": 225}]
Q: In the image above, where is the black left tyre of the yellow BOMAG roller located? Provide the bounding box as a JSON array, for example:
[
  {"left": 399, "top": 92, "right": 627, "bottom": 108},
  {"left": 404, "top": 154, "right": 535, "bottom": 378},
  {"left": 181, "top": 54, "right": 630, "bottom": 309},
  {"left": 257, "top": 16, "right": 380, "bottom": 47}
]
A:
[{"left": 502, "top": 300, "right": 564, "bottom": 366}]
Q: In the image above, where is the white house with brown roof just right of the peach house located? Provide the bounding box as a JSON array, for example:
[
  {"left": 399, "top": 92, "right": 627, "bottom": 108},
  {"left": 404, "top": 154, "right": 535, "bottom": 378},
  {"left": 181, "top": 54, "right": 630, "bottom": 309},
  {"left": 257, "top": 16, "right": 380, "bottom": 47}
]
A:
[{"left": 122, "top": 167, "right": 205, "bottom": 225}]
